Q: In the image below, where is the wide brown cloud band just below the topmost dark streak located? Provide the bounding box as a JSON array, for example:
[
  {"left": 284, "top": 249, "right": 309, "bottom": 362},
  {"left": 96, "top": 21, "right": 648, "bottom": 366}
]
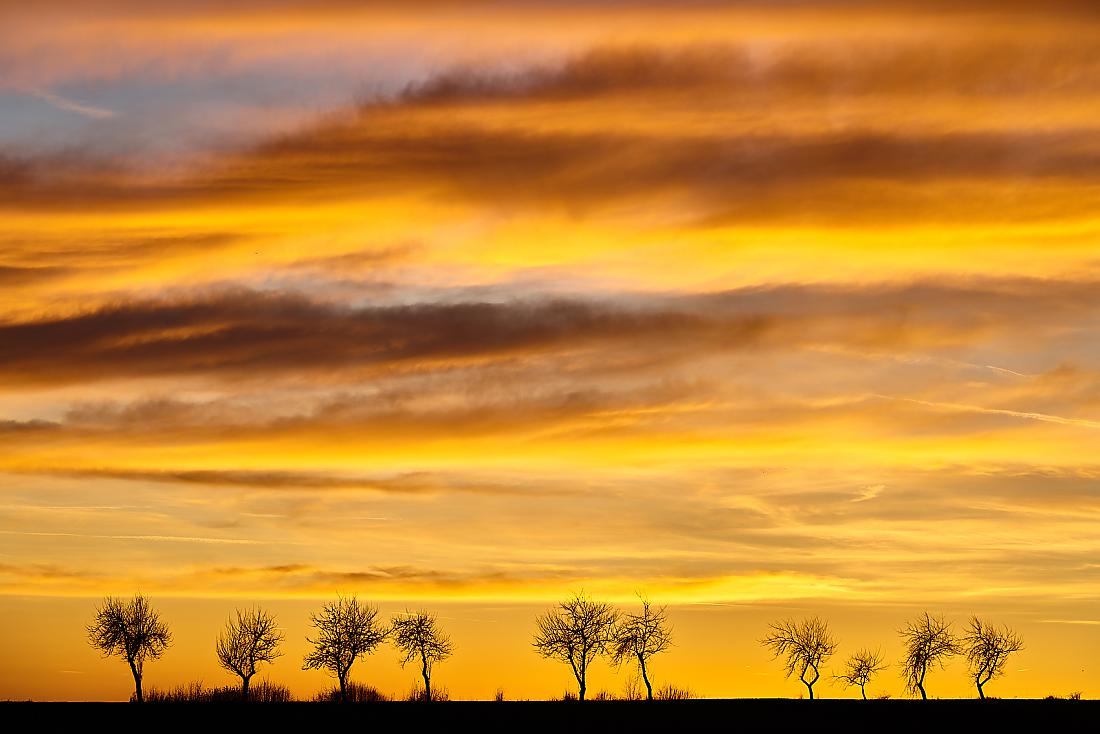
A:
[{"left": 10, "top": 129, "right": 1100, "bottom": 219}]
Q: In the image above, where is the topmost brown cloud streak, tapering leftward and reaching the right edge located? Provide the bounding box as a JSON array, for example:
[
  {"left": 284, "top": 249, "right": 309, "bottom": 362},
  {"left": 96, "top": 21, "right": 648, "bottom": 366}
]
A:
[{"left": 404, "top": 37, "right": 1100, "bottom": 103}]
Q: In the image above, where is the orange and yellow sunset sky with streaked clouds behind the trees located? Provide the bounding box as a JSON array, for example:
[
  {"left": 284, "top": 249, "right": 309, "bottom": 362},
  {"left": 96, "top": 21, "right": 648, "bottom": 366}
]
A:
[{"left": 0, "top": 0, "right": 1100, "bottom": 700}]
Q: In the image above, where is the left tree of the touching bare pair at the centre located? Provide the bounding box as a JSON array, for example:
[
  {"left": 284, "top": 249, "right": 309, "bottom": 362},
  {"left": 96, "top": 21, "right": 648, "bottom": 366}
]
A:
[{"left": 534, "top": 592, "right": 618, "bottom": 701}]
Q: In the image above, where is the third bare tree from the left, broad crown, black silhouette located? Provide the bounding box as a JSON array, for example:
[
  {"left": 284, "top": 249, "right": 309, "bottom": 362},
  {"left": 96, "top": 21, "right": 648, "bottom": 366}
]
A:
[{"left": 301, "top": 596, "right": 389, "bottom": 701}]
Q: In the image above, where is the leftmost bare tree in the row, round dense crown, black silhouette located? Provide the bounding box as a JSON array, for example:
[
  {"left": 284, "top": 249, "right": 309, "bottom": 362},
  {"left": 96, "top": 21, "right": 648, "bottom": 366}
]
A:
[{"left": 87, "top": 594, "right": 172, "bottom": 703}]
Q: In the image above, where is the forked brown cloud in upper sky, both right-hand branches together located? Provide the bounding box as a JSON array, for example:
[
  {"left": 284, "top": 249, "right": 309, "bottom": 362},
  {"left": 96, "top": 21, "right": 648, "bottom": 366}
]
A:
[{"left": 8, "top": 41, "right": 1100, "bottom": 220}]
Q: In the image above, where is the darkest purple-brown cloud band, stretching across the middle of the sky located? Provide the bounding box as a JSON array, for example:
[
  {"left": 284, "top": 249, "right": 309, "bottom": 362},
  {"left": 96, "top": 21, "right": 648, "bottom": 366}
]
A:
[{"left": 0, "top": 280, "right": 1100, "bottom": 385}]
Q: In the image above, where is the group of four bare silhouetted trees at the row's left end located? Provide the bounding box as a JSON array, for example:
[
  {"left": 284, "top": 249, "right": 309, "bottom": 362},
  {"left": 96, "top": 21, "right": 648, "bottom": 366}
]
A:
[{"left": 87, "top": 594, "right": 454, "bottom": 702}]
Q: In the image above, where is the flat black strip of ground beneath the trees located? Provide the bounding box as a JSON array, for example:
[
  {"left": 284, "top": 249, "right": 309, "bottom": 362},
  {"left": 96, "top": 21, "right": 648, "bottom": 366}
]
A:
[{"left": 0, "top": 699, "right": 1100, "bottom": 734}]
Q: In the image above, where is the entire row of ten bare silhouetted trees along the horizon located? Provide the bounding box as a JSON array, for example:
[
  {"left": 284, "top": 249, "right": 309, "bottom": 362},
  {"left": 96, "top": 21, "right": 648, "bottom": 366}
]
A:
[{"left": 88, "top": 593, "right": 1023, "bottom": 701}]
